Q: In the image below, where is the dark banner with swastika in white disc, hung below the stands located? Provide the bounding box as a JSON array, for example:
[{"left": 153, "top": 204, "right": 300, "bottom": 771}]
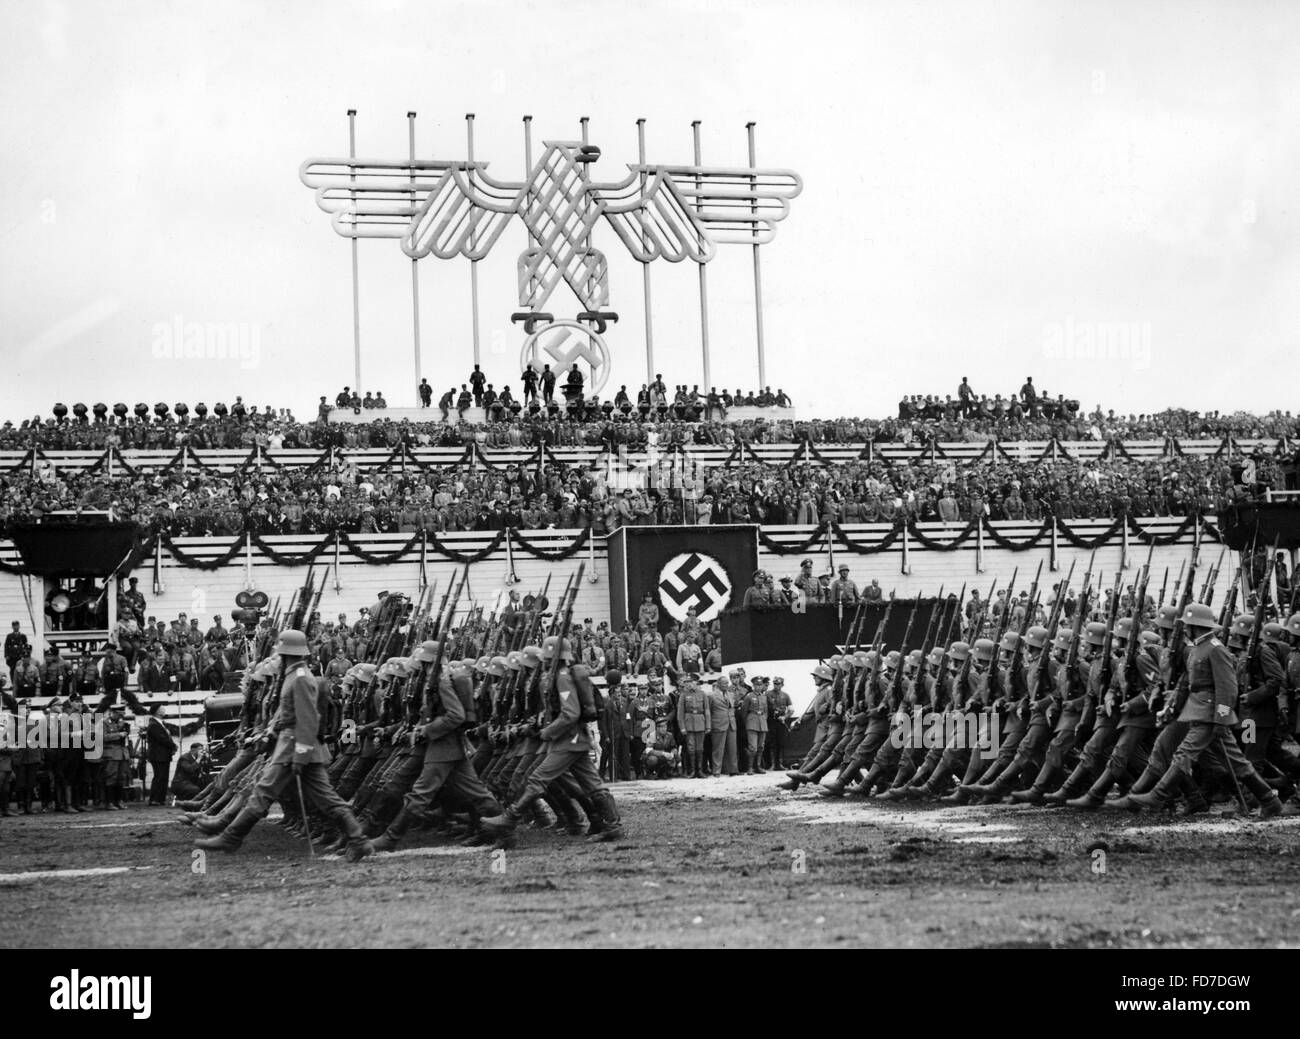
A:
[{"left": 610, "top": 525, "right": 758, "bottom": 631}]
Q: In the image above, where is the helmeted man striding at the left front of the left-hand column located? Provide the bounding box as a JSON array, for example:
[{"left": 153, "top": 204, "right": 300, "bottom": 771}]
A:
[{"left": 194, "top": 628, "right": 374, "bottom": 862}]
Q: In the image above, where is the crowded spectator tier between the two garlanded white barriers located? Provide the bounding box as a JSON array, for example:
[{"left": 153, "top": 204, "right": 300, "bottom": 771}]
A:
[{"left": 0, "top": 453, "right": 1283, "bottom": 536}]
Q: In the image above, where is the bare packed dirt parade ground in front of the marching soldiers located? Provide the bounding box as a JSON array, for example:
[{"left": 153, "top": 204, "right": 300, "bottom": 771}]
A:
[{"left": 0, "top": 774, "right": 1300, "bottom": 948}]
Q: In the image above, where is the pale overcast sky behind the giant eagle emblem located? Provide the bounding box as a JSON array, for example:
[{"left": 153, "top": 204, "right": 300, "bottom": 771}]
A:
[{"left": 0, "top": 0, "right": 1300, "bottom": 419}]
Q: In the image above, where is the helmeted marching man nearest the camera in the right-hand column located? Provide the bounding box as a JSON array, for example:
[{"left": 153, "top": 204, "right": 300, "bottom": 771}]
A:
[{"left": 1115, "top": 602, "right": 1282, "bottom": 819}]
